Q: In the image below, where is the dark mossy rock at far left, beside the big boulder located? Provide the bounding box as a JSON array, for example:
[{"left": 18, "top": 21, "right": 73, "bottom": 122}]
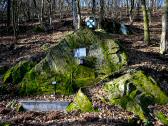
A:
[{"left": 3, "top": 60, "right": 35, "bottom": 84}]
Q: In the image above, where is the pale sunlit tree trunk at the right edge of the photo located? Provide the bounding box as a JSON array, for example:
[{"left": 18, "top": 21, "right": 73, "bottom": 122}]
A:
[{"left": 160, "top": 0, "right": 168, "bottom": 54}]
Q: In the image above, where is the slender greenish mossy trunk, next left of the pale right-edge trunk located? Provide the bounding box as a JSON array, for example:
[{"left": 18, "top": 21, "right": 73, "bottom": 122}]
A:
[{"left": 141, "top": 0, "right": 150, "bottom": 44}]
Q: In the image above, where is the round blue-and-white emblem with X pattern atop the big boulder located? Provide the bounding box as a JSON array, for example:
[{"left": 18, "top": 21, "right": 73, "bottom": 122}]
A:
[{"left": 85, "top": 17, "right": 96, "bottom": 29}]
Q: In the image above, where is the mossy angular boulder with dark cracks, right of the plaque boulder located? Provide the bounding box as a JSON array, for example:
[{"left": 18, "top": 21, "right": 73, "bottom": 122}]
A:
[{"left": 104, "top": 71, "right": 168, "bottom": 120}]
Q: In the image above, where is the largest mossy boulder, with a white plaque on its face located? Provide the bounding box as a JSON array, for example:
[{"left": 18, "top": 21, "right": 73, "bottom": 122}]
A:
[{"left": 20, "top": 29, "right": 127, "bottom": 94}]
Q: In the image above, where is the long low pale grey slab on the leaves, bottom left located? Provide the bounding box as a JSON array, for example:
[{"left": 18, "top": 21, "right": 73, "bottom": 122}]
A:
[{"left": 19, "top": 100, "right": 69, "bottom": 111}]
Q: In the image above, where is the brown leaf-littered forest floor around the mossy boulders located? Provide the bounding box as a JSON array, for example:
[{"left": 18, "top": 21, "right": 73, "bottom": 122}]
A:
[{"left": 0, "top": 14, "right": 168, "bottom": 126}]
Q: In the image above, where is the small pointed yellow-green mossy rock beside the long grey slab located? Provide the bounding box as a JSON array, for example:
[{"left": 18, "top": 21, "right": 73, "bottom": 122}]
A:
[{"left": 66, "top": 90, "right": 94, "bottom": 112}]
